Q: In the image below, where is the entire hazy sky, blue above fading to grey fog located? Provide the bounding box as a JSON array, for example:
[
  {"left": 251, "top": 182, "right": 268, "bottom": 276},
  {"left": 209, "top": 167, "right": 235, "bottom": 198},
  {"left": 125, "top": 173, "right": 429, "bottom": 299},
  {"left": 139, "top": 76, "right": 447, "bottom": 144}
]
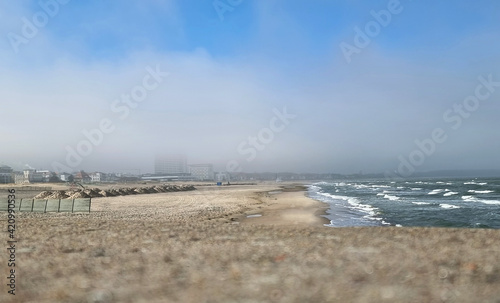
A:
[{"left": 0, "top": 0, "right": 500, "bottom": 176}]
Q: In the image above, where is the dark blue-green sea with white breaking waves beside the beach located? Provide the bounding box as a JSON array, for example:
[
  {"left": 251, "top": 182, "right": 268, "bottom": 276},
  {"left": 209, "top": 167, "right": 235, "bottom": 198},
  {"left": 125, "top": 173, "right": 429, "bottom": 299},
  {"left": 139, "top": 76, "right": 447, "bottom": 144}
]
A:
[{"left": 308, "top": 178, "right": 500, "bottom": 229}]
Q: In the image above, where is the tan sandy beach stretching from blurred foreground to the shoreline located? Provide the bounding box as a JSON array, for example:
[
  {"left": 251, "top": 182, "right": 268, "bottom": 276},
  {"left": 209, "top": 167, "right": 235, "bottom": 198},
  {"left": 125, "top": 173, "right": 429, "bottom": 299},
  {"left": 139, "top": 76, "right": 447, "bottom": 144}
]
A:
[{"left": 0, "top": 184, "right": 500, "bottom": 303}]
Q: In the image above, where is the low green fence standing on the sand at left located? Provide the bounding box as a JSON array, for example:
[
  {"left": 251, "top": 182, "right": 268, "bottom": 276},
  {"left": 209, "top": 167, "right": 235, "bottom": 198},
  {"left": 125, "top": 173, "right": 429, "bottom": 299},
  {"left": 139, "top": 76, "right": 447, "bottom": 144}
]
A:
[{"left": 0, "top": 198, "right": 92, "bottom": 213}]
